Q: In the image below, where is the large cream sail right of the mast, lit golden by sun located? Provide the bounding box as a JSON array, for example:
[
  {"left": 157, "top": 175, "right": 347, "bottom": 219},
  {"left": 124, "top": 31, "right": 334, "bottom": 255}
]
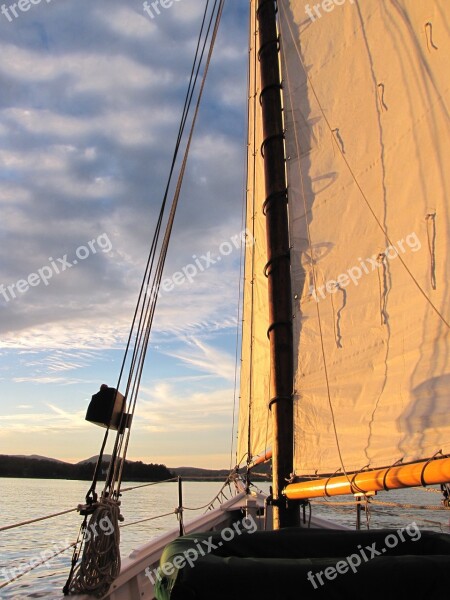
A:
[{"left": 278, "top": 0, "right": 450, "bottom": 475}]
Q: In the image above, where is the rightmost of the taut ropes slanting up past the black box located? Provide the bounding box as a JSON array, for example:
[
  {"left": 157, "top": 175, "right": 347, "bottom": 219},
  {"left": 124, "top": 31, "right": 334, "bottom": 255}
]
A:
[{"left": 117, "top": 0, "right": 224, "bottom": 492}]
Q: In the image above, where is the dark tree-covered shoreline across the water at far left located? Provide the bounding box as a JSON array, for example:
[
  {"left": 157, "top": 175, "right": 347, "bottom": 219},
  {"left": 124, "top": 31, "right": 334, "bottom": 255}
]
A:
[{"left": 0, "top": 455, "right": 174, "bottom": 481}]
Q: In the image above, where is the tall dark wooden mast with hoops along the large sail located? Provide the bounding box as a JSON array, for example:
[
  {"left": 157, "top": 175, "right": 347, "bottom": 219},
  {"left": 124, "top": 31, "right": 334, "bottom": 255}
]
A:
[{"left": 257, "top": 0, "right": 298, "bottom": 529}]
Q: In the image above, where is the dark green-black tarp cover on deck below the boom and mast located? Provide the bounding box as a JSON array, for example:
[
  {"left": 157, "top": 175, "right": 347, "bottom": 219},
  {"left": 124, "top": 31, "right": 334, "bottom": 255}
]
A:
[{"left": 155, "top": 523, "right": 450, "bottom": 600}]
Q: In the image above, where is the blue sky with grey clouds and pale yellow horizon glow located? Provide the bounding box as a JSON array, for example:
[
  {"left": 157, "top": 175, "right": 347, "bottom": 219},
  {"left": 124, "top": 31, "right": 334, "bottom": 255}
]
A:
[{"left": 0, "top": 0, "right": 248, "bottom": 468}]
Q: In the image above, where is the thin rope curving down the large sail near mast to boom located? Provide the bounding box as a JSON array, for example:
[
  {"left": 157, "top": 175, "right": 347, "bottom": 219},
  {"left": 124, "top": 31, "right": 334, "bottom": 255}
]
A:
[{"left": 280, "top": 2, "right": 358, "bottom": 489}]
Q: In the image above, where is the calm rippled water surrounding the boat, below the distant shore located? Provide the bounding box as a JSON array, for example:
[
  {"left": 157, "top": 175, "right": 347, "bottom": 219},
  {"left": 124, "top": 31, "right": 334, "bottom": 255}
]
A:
[{"left": 0, "top": 478, "right": 450, "bottom": 600}]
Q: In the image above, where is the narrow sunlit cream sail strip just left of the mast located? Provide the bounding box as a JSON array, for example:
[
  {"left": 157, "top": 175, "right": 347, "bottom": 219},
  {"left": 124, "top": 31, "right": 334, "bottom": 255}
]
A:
[{"left": 238, "top": 0, "right": 272, "bottom": 462}]
